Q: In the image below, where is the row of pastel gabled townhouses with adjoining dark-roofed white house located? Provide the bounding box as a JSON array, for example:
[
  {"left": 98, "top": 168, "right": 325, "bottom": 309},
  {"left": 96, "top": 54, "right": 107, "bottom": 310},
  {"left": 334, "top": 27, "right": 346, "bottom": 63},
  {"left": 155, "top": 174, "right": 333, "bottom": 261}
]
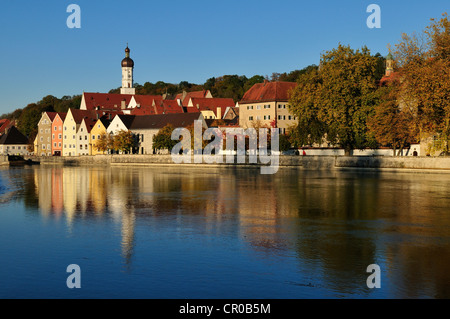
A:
[{"left": 34, "top": 109, "right": 207, "bottom": 156}]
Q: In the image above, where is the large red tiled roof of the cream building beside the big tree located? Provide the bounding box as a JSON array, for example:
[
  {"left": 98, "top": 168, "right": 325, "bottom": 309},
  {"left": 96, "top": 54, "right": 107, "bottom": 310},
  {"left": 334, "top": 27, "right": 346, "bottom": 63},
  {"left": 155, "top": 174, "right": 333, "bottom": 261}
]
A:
[{"left": 240, "top": 82, "right": 297, "bottom": 103}]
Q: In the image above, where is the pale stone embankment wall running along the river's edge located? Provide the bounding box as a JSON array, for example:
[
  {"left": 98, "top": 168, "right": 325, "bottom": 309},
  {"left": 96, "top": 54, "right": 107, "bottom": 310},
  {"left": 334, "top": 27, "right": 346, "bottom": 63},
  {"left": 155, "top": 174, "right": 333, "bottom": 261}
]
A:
[{"left": 0, "top": 155, "right": 450, "bottom": 173}]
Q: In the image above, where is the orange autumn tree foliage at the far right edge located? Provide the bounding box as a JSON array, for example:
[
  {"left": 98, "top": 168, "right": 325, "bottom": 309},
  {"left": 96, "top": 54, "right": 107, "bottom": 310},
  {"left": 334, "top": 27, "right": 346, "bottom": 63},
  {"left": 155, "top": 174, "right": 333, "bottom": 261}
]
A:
[{"left": 395, "top": 13, "right": 450, "bottom": 151}]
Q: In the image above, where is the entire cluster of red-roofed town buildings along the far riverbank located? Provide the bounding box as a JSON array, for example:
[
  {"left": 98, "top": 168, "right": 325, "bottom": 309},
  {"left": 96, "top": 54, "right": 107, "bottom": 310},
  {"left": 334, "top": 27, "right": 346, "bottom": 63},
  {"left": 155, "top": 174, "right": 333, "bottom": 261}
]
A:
[{"left": 34, "top": 81, "right": 296, "bottom": 156}]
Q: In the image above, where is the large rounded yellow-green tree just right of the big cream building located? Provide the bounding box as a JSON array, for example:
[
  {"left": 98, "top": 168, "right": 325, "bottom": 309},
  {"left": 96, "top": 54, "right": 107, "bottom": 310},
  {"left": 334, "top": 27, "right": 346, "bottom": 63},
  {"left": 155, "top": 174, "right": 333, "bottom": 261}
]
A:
[{"left": 289, "top": 45, "right": 378, "bottom": 155}]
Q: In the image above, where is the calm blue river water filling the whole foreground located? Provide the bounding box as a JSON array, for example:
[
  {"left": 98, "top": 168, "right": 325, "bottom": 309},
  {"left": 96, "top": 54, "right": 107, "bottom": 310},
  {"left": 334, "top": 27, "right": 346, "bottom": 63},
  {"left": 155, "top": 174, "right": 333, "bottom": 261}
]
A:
[{"left": 0, "top": 166, "right": 450, "bottom": 299}]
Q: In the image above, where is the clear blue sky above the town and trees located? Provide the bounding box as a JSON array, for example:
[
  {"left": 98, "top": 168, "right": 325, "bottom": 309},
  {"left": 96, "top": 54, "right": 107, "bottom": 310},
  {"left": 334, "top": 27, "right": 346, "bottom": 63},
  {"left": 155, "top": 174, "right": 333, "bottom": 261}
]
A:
[{"left": 0, "top": 0, "right": 450, "bottom": 114}]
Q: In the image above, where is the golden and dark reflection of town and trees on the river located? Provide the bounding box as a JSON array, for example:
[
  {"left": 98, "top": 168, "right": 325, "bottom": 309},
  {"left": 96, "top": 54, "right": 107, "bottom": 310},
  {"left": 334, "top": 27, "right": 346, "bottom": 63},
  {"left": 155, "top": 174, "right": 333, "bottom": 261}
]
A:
[{"left": 11, "top": 166, "right": 450, "bottom": 298}]
